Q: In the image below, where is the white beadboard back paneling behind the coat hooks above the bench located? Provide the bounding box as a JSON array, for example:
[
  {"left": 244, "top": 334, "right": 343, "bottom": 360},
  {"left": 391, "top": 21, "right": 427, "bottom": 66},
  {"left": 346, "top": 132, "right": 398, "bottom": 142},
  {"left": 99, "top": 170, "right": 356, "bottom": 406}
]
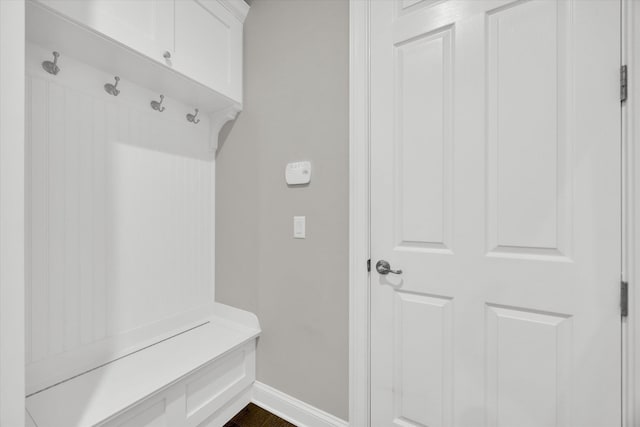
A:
[{"left": 27, "top": 45, "right": 215, "bottom": 392}]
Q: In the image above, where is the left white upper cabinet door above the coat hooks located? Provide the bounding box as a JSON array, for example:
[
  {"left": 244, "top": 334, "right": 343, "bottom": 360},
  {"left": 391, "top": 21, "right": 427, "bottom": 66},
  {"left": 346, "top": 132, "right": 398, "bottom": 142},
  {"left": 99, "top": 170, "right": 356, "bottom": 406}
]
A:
[{"left": 39, "top": 0, "right": 174, "bottom": 63}]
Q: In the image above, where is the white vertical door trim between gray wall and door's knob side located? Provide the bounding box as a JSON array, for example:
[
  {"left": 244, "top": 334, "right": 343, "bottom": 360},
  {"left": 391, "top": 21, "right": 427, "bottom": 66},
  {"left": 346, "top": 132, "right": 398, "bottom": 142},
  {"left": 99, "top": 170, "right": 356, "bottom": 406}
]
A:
[{"left": 349, "top": 0, "right": 371, "bottom": 427}]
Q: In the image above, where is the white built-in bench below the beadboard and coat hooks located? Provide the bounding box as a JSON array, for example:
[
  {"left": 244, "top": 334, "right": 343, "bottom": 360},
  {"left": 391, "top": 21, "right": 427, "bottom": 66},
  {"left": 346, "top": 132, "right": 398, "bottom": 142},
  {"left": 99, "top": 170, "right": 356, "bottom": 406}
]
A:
[{"left": 27, "top": 304, "right": 260, "bottom": 427}]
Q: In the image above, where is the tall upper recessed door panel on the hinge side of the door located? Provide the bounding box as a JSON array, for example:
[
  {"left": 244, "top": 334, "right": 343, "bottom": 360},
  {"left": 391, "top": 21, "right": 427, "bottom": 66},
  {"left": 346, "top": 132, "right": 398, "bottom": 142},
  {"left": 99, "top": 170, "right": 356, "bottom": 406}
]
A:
[{"left": 485, "top": 0, "right": 575, "bottom": 261}]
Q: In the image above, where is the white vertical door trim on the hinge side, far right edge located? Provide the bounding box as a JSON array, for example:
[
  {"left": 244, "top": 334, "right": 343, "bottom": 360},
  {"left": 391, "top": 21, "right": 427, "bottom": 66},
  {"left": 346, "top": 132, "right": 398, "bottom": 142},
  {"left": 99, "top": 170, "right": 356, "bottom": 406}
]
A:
[{"left": 621, "top": 0, "right": 640, "bottom": 427}]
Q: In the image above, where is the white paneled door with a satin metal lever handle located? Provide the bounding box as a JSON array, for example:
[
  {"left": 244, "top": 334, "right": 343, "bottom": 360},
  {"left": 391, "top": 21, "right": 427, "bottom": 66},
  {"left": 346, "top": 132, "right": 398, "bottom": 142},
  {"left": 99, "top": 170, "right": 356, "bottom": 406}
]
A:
[{"left": 371, "top": 0, "right": 621, "bottom": 427}]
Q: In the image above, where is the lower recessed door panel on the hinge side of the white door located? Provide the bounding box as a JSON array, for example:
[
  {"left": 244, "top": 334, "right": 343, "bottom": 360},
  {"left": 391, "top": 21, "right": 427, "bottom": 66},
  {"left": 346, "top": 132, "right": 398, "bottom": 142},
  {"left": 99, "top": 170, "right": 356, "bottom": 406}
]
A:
[{"left": 485, "top": 304, "right": 573, "bottom": 427}]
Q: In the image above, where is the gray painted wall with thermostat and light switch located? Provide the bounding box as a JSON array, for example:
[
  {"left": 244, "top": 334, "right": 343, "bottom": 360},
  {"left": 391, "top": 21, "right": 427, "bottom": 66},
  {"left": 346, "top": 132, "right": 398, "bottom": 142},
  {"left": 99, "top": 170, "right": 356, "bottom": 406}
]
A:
[{"left": 216, "top": 0, "right": 349, "bottom": 419}]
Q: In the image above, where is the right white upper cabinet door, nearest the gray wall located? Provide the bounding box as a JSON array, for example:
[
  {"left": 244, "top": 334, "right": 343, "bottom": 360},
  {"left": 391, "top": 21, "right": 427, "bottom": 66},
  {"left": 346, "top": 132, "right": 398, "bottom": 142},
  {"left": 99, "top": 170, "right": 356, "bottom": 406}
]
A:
[{"left": 173, "top": 0, "right": 242, "bottom": 101}]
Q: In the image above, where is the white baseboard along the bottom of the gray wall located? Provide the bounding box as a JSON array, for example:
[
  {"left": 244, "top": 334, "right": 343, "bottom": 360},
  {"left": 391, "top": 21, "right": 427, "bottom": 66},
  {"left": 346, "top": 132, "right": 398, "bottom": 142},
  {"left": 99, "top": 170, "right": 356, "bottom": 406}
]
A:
[{"left": 253, "top": 381, "right": 349, "bottom": 427}]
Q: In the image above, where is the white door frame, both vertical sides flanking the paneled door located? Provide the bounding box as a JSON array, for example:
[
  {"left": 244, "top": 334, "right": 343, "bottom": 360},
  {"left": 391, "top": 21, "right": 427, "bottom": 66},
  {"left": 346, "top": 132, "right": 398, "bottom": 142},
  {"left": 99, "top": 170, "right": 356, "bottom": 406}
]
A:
[{"left": 349, "top": 0, "right": 640, "bottom": 427}]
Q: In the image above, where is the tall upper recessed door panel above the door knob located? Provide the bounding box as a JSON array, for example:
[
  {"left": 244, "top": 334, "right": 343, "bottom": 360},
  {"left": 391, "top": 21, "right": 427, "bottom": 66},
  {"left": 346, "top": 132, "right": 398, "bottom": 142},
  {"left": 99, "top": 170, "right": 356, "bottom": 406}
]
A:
[{"left": 394, "top": 25, "right": 454, "bottom": 253}]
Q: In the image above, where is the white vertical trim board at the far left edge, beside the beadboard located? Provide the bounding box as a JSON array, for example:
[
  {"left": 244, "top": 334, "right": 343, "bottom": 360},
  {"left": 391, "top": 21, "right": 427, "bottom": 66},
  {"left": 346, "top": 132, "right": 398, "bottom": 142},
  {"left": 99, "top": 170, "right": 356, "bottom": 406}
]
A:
[{"left": 0, "top": 0, "right": 25, "bottom": 426}]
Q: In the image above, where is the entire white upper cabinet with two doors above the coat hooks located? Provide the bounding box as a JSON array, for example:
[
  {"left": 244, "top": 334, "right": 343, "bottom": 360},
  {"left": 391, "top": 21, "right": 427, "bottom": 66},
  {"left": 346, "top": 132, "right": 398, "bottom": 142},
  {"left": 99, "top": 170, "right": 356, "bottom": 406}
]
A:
[{"left": 36, "top": 0, "right": 249, "bottom": 103}]
